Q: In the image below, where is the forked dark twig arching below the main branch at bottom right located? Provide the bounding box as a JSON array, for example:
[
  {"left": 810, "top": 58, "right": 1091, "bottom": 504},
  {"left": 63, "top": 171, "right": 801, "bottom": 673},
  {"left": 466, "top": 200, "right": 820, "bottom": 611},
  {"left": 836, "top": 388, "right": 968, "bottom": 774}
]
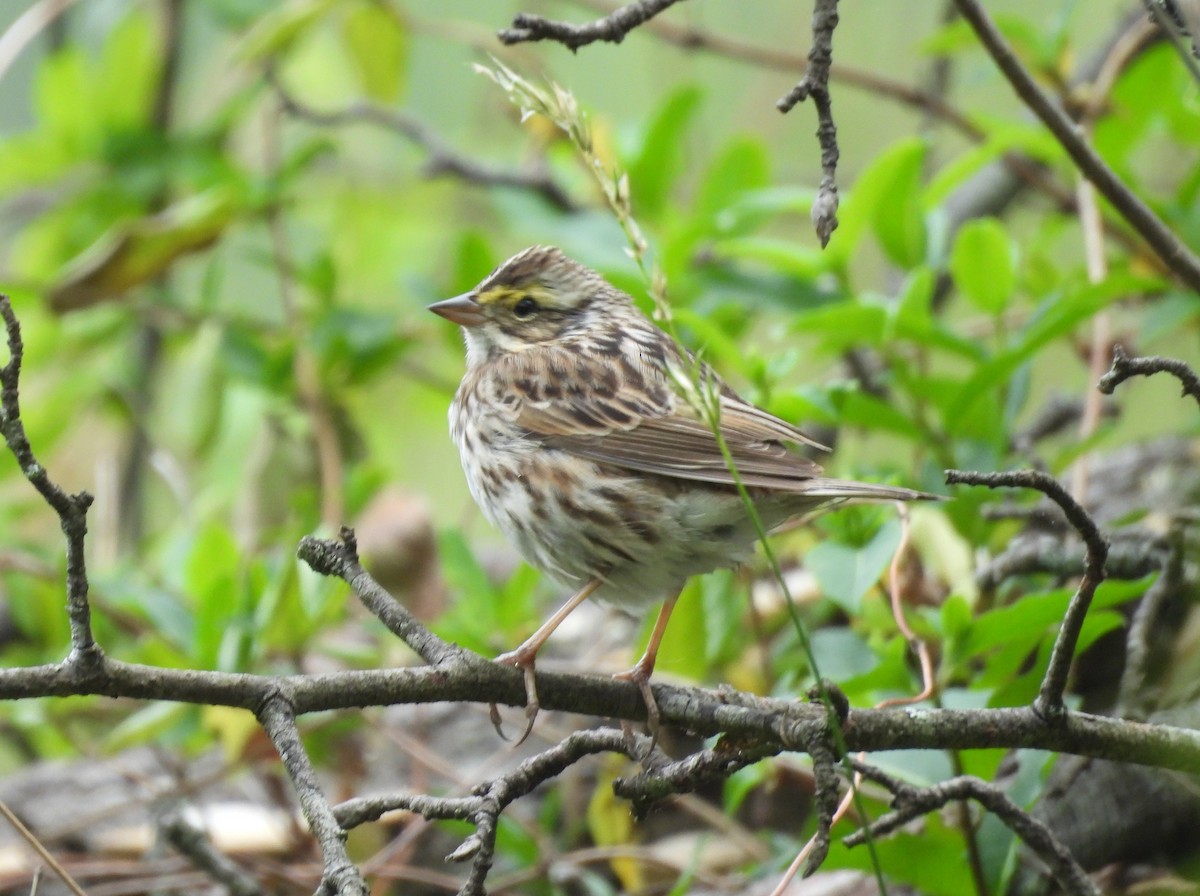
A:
[{"left": 846, "top": 760, "right": 1100, "bottom": 896}]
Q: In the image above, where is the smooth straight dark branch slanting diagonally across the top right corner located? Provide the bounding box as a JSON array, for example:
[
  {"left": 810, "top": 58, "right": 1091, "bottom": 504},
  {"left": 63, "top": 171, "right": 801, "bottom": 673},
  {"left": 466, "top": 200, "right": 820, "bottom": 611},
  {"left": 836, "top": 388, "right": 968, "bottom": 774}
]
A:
[{"left": 954, "top": 0, "right": 1200, "bottom": 290}]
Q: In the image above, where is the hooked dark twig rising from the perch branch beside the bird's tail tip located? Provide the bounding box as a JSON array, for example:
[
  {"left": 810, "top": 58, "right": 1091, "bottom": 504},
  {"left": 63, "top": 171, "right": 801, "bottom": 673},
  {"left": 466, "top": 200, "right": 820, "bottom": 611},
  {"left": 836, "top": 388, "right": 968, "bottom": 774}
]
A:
[{"left": 946, "top": 470, "right": 1109, "bottom": 721}]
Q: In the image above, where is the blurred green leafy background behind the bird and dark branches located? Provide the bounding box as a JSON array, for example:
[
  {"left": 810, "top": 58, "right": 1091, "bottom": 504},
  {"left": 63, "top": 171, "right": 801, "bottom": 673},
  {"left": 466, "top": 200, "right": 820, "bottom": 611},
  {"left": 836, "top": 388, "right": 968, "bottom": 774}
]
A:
[{"left": 0, "top": 0, "right": 1200, "bottom": 894}]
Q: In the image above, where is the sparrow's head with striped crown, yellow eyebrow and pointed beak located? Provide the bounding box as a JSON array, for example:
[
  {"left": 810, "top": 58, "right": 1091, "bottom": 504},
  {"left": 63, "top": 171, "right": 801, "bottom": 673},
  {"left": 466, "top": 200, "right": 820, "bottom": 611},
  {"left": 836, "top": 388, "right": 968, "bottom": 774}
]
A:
[{"left": 430, "top": 246, "right": 631, "bottom": 365}]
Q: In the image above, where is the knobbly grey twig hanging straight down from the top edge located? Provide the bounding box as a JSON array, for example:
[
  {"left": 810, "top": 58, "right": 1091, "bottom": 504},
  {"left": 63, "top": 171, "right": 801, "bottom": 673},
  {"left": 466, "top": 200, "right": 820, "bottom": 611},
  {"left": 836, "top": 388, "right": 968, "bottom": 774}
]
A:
[{"left": 775, "top": 0, "right": 839, "bottom": 248}]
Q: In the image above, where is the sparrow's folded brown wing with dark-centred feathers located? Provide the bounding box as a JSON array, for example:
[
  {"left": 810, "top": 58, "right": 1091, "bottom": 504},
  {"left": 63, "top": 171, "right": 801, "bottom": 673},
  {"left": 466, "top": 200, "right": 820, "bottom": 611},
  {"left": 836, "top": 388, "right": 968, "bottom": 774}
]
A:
[{"left": 509, "top": 345, "right": 823, "bottom": 491}]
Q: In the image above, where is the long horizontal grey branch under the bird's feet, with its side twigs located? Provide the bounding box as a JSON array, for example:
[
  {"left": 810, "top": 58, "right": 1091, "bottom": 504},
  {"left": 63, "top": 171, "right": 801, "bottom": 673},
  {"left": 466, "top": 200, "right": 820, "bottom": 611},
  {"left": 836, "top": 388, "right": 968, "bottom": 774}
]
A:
[{"left": 0, "top": 292, "right": 1200, "bottom": 894}]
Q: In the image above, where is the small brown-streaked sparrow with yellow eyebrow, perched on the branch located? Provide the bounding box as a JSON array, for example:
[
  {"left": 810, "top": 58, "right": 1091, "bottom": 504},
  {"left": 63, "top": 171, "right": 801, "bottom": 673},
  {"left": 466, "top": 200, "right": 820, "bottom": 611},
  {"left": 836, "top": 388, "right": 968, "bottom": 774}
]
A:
[{"left": 430, "top": 246, "right": 931, "bottom": 734}]
